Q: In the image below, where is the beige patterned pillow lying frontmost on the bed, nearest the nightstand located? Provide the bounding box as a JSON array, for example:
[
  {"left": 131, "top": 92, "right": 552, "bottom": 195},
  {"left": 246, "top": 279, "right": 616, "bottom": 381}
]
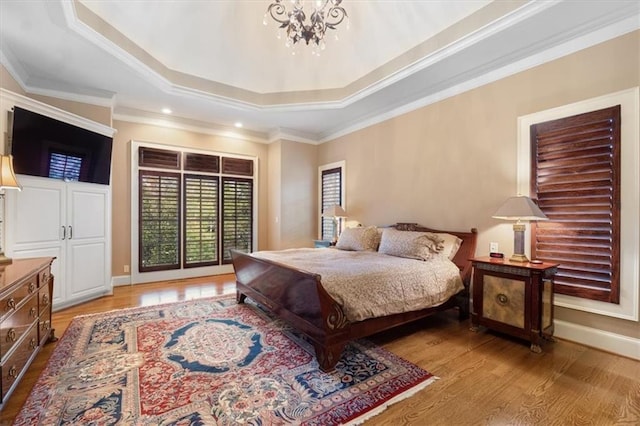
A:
[{"left": 378, "top": 228, "right": 444, "bottom": 260}]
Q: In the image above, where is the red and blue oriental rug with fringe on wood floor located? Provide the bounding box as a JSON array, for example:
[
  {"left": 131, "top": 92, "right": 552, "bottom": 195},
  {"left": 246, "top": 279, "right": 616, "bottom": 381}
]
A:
[{"left": 15, "top": 297, "right": 436, "bottom": 425}]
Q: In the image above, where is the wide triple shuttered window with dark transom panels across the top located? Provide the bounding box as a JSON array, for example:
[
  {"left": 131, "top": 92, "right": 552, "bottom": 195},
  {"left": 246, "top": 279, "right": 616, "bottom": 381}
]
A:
[{"left": 138, "top": 147, "right": 254, "bottom": 272}]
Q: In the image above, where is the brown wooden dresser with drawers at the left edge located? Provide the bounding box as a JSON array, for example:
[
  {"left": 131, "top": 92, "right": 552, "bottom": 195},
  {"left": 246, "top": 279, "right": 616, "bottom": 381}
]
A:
[{"left": 0, "top": 257, "right": 56, "bottom": 410}]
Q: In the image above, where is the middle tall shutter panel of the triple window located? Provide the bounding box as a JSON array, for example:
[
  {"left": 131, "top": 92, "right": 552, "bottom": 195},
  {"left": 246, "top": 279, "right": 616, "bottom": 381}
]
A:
[{"left": 183, "top": 174, "right": 219, "bottom": 267}]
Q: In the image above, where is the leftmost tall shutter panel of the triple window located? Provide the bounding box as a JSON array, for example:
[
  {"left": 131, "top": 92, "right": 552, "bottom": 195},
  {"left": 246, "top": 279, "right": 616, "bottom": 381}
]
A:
[{"left": 138, "top": 170, "right": 180, "bottom": 272}]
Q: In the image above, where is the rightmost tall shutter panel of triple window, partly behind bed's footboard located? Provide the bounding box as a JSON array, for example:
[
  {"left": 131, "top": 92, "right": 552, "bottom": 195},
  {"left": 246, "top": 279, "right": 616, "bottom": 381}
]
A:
[{"left": 222, "top": 177, "right": 253, "bottom": 263}]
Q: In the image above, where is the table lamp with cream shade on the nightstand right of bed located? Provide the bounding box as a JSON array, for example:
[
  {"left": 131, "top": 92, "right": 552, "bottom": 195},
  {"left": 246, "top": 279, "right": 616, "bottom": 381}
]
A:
[{"left": 492, "top": 195, "right": 548, "bottom": 262}]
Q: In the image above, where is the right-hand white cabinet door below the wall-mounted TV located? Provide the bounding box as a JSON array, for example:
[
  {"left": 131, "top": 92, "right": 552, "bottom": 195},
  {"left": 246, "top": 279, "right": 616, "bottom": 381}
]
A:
[{"left": 67, "top": 183, "right": 111, "bottom": 299}]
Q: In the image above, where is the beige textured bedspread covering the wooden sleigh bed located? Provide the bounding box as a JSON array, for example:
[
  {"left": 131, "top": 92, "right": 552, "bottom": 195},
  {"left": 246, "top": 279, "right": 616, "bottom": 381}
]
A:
[{"left": 253, "top": 248, "right": 464, "bottom": 321}]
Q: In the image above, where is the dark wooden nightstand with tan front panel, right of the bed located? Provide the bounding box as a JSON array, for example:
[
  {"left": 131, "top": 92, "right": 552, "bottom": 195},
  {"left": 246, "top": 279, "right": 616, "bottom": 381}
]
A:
[{"left": 471, "top": 257, "right": 559, "bottom": 353}]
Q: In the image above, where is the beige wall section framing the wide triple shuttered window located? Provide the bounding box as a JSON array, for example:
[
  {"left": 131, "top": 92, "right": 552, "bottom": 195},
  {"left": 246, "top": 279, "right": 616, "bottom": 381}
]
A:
[{"left": 111, "top": 120, "right": 268, "bottom": 276}]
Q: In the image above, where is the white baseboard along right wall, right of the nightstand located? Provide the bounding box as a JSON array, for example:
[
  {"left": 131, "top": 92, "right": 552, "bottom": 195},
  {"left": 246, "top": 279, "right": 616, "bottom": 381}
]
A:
[{"left": 553, "top": 320, "right": 640, "bottom": 360}]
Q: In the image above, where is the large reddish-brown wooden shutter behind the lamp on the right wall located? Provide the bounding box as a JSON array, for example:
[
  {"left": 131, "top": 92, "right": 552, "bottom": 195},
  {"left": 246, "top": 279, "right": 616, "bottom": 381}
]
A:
[{"left": 531, "top": 105, "right": 620, "bottom": 303}]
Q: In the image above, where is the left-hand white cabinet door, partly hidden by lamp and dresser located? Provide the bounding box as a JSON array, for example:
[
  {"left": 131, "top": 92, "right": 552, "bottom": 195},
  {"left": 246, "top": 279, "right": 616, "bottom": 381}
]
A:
[{"left": 3, "top": 175, "right": 66, "bottom": 304}]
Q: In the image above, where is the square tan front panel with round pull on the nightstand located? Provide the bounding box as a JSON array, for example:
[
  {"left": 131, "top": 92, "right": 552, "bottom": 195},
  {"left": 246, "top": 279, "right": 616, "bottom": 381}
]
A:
[{"left": 482, "top": 275, "right": 525, "bottom": 328}]
